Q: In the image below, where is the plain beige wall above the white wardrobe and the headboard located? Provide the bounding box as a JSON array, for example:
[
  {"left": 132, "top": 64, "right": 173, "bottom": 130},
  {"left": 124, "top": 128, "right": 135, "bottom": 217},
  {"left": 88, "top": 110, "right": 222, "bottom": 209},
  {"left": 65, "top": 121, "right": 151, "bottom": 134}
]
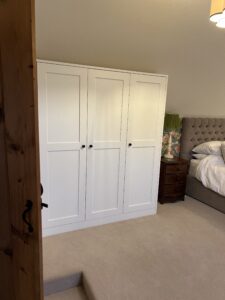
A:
[{"left": 36, "top": 0, "right": 225, "bottom": 116}]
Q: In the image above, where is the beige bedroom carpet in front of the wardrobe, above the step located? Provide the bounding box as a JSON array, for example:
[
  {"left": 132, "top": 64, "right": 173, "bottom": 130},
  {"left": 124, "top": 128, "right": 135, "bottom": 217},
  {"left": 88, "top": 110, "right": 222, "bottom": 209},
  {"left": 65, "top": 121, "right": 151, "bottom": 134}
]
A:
[{"left": 44, "top": 198, "right": 225, "bottom": 300}]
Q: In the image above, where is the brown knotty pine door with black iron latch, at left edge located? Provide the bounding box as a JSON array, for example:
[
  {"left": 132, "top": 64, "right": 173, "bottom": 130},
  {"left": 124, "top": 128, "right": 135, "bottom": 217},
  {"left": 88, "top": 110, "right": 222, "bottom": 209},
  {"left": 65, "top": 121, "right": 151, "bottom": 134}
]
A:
[{"left": 0, "top": 0, "right": 43, "bottom": 300}]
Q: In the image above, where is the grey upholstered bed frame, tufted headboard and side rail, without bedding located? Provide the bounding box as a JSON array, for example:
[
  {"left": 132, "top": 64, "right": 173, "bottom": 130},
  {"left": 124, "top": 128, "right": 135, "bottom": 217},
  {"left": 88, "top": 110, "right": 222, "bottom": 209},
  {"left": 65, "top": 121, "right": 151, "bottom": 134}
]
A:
[{"left": 181, "top": 118, "right": 225, "bottom": 213}]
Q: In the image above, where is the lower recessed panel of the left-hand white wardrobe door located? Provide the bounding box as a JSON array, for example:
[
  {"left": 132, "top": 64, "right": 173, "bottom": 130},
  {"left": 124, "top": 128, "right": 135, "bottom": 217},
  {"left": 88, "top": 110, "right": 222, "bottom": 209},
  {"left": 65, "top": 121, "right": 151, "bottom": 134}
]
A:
[{"left": 48, "top": 151, "right": 80, "bottom": 225}]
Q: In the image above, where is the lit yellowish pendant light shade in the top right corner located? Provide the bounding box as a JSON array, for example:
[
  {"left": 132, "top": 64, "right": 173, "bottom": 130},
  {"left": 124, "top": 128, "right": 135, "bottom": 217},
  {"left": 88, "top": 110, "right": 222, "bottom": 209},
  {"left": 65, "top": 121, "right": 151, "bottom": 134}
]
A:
[{"left": 210, "top": 0, "right": 225, "bottom": 24}]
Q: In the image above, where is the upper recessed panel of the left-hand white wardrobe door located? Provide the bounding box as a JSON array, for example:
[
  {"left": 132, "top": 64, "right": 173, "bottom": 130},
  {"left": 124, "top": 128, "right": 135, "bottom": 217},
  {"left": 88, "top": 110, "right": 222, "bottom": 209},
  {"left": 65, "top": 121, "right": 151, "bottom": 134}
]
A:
[{"left": 46, "top": 73, "right": 80, "bottom": 143}]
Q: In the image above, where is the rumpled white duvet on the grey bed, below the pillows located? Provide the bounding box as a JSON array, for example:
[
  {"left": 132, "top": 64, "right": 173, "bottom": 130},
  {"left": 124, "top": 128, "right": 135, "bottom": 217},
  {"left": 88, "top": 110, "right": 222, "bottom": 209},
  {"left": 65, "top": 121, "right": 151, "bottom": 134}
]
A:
[{"left": 195, "top": 155, "right": 225, "bottom": 196}]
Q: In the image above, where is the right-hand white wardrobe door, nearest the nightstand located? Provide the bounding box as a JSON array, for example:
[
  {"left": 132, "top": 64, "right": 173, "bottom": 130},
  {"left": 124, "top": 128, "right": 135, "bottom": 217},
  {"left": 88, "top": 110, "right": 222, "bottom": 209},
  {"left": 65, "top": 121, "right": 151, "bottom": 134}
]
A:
[{"left": 124, "top": 75, "right": 166, "bottom": 212}]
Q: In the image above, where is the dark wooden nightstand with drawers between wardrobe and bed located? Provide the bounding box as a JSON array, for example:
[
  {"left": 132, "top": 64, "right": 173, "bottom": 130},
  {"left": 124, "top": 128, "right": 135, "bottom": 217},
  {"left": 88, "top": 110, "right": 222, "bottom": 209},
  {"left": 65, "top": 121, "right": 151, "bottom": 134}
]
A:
[{"left": 159, "top": 158, "right": 189, "bottom": 204}]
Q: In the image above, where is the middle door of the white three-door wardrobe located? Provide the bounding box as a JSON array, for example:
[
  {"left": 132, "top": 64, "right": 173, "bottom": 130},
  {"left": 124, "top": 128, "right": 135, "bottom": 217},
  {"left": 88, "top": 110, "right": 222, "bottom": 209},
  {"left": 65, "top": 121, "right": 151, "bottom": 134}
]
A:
[{"left": 86, "top": 70, "right": 130, "bottom": 219}]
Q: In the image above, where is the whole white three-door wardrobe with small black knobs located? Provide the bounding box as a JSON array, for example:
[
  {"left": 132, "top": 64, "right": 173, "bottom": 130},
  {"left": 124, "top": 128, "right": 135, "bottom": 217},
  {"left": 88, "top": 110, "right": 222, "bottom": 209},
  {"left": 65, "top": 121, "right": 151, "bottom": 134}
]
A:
[{"left": 38, "top": 61, "right": 167, "bottom": 235}]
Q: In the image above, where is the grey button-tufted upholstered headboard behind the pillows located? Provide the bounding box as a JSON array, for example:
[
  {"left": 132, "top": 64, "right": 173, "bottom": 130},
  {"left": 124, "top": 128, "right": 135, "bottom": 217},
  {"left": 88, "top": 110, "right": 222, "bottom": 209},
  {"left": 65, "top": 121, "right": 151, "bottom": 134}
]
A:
[{"left": 181, "top": 118, "right": 225, "bottom": 159}]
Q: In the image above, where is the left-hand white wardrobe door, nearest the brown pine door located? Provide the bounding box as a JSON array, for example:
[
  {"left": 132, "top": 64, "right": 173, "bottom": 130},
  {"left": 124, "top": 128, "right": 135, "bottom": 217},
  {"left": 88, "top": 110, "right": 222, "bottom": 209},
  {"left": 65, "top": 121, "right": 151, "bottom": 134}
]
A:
[{"left": 38, "top": 63, "right": 87, "bottom": 232}]
